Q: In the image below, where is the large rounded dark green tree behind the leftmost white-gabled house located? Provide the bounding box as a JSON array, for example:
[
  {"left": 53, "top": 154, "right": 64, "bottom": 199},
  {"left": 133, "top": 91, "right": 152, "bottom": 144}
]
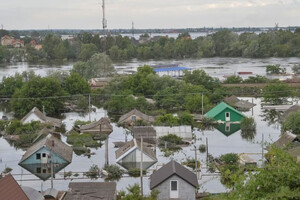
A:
[{"left": 10, "top": 76, "right": 67, "bottom": 117}]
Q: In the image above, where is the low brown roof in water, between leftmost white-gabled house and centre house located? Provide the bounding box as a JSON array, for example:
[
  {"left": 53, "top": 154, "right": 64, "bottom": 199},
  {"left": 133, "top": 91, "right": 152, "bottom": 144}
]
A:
[{"left": 79, "top": 117, "right": 113, "bottom": 135}]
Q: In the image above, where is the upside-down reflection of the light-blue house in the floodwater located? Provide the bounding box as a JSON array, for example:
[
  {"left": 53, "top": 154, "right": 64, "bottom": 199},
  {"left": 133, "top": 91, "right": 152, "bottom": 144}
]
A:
[{"left": 20, "top": 164, "right": 69, "bottom": 181}]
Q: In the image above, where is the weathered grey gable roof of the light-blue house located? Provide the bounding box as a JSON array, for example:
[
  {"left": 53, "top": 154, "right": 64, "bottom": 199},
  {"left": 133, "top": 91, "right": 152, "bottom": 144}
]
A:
[{"left": 19, "top": 134, "right": 73, "bottom": 164}]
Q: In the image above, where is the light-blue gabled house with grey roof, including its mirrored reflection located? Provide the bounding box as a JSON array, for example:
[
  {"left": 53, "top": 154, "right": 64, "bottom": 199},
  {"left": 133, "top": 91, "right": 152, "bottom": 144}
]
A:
[{"left": 19, "top": 134, "right": 73, "bottom": 180}]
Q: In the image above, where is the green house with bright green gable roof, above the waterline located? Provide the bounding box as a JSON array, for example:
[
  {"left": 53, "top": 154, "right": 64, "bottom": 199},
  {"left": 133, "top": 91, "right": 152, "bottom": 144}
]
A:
[{"left": 204, "top": 102, "right": 245, "bottom": 122}]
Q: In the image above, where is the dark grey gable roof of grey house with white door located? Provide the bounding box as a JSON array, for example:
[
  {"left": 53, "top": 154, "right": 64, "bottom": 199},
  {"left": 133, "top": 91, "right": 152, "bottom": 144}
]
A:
[{"left": 150, "top": 160, "right": 198, "bottom": 190}]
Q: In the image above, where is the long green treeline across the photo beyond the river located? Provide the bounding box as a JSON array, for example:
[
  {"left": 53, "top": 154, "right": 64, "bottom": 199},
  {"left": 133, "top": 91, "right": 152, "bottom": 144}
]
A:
[{"left": 0, "top": 29, "right": 300, "bottom": 63}]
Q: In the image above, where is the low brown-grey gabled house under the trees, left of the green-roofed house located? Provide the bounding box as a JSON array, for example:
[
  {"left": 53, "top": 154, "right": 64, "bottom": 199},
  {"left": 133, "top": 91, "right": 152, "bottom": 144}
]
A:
[{"left": 118, "top": 109, "right": 155, "bottom": 125}]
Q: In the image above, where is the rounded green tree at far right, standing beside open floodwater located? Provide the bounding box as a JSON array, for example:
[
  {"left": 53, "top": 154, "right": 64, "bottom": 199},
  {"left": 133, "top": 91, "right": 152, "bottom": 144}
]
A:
[{"left": 262, "top": 82, "right": 292, "bottom": 104}]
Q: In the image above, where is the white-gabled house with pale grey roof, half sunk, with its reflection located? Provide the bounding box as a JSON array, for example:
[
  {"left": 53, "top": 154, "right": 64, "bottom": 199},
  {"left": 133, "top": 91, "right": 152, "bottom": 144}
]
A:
[{"left": 116, "top": 139, "right": 157, "bottom": 170}]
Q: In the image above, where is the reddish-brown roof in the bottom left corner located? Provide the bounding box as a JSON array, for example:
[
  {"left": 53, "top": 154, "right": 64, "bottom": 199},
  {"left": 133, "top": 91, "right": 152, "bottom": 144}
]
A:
[{"left": 0, "top": 174, "right": 29, "bottom": 200}]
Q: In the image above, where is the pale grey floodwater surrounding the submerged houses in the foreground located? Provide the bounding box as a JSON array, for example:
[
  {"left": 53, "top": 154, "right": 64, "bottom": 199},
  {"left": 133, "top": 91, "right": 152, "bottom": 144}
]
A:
[{"left": 0, "top": 98, "right": 280, "bottom": 194}]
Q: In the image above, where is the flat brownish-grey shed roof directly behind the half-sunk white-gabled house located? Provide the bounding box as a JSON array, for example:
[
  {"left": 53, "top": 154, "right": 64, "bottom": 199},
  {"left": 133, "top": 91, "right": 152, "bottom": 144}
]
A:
[{"left": 132, "top": 126, "right": 156, "bottom": 144}]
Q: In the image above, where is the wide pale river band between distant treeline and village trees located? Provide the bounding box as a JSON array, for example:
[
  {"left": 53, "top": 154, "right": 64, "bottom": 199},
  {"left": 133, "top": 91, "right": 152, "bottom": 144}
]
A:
[{"left": 0, "top": 57, "right": 300, "bottom": 81}]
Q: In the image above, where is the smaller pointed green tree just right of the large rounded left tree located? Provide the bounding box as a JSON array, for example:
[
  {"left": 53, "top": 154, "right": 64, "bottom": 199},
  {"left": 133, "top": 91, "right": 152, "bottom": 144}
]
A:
[{"left": 66, "top": 72, "right": 91, "bottom": 94}]
